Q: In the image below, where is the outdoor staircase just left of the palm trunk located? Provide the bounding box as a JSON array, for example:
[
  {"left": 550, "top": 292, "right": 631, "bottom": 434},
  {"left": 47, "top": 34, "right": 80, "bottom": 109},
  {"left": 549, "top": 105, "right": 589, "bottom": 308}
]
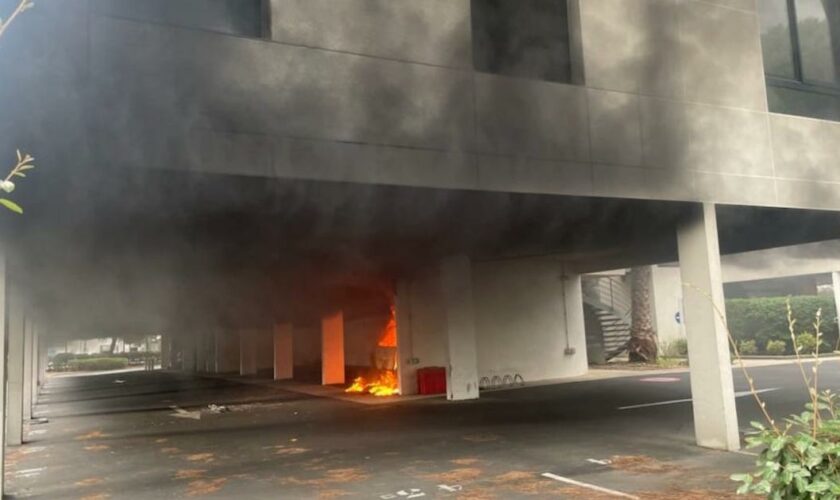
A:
[{"left": 583, "top": 275, "right": 632, "bottom": 364}]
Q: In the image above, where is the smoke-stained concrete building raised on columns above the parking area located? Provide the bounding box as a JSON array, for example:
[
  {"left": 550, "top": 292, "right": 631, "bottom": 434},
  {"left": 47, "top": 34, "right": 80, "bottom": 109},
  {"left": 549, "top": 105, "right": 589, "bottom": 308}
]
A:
[{"left": 0, "top": 0, "right": 840, "bottom": 464}]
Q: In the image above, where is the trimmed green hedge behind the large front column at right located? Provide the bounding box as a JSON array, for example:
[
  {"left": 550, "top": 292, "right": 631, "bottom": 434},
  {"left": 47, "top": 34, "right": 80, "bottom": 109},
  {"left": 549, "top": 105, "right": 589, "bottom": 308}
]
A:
[{"left": 726, "top": 295, "right": 838, "bottom": 354}]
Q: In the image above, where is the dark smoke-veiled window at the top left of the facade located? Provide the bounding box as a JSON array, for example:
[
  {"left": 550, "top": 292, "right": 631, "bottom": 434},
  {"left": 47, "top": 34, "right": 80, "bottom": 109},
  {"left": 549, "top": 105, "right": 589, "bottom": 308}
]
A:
[{"left": 94, "top": 0, "right": 263, "bottom": 38}]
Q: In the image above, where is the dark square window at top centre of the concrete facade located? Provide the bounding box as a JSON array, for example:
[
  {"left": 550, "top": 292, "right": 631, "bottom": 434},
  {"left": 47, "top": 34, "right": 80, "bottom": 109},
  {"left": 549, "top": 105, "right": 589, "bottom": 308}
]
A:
[{"left": 472, "top": 0, "right": 571, "bottom": 82}]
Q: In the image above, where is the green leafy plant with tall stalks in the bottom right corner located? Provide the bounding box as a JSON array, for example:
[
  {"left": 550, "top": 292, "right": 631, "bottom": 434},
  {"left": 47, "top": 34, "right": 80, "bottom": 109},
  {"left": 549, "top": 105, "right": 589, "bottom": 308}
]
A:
[{"left": 730, "top": 302, "right": 840, "bottom": 500}]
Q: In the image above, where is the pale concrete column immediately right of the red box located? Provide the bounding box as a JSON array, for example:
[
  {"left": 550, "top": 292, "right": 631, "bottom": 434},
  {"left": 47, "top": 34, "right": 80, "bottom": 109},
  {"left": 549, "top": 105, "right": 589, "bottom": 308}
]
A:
[{"left": 440, "top": 256, "right": 478, "bottom": 401}]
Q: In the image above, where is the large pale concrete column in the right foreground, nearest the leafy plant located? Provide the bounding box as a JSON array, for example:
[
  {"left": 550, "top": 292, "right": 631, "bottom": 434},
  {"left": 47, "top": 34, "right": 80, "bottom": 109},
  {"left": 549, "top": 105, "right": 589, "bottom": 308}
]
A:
[{"left": 677, "top": 203, "right": 740, "bottom": 450}]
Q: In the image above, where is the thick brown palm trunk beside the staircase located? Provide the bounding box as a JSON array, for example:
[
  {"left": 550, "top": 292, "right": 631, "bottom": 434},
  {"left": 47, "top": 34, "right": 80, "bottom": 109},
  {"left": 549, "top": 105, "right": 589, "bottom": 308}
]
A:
[{"left": 627, "top": 266, "right": 657, "bottom": 363}]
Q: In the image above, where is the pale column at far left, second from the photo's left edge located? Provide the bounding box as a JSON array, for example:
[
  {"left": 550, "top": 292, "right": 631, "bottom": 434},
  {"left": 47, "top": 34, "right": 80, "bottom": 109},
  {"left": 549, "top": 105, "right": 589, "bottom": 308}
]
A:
[{"left": 6, "top": 288, "right": 26, "bottom": 446}]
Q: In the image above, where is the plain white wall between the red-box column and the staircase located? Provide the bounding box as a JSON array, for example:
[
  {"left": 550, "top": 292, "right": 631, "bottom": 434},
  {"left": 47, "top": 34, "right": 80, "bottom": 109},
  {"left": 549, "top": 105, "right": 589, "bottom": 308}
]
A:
[{"left": 473, "top": 257, "right": 587, "bottom": 381}]
